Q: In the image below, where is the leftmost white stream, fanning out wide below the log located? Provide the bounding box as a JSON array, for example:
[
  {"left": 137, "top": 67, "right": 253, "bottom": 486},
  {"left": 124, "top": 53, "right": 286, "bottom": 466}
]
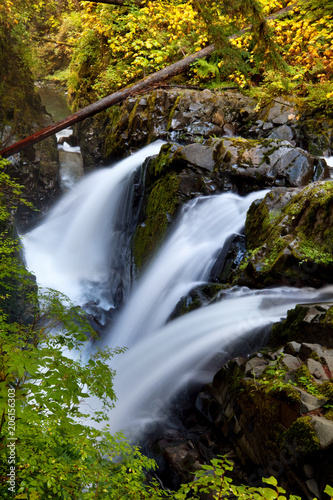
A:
[{"left": 23, "top": 141, "right": 163, "bottom": 309}]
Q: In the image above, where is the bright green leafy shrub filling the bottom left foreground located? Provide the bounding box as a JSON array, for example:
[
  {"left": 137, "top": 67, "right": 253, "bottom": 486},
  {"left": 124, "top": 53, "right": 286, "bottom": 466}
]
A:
[{"left": 0, "top": 155, "right": 160, "bottom": 500}]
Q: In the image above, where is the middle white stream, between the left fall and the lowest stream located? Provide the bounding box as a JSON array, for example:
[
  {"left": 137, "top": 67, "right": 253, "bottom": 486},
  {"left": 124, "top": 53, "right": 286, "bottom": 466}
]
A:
[{"left": 107, "top": 191, "right": 267, "bottom": 347}]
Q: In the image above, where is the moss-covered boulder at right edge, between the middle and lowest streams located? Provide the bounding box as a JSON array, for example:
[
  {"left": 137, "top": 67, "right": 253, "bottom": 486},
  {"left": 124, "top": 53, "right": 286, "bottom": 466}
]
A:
[{"left": 234, "top": 181, "right": 333, "bottom": 287}]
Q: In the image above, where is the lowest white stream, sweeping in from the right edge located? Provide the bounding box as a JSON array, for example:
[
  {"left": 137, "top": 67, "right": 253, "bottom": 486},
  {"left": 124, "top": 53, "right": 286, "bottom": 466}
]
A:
[{"left": 87, "top": 287, "right": 333, "bottom": 436}]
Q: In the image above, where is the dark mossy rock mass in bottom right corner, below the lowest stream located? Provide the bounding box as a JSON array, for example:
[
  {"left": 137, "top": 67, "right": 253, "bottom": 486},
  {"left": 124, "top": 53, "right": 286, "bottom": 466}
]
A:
[{"left": 197, "top": 341, "right": 333, "bottom": 498}]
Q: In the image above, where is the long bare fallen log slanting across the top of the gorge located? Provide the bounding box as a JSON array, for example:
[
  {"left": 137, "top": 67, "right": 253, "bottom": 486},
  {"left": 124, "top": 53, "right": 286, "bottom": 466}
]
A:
[{"left": 0, "top": 4, "right": 295, "bottom": 158}]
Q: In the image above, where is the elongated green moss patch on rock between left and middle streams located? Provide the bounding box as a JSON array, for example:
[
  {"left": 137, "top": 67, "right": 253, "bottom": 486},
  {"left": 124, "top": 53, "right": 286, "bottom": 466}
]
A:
[{"left": 133, "top": 174, "right": 180, "bottom": 269}]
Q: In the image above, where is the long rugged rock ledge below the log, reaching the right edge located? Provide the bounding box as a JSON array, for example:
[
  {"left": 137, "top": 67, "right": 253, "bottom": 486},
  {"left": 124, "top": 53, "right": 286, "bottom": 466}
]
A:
[{"left": 78, "top": 88, "right": 333, "bottom": 168}]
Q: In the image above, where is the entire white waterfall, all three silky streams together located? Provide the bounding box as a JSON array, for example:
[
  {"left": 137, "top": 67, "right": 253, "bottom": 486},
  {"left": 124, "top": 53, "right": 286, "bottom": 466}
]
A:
[{"left": 24, "top": 143, "right": 333, "bottom": 440}]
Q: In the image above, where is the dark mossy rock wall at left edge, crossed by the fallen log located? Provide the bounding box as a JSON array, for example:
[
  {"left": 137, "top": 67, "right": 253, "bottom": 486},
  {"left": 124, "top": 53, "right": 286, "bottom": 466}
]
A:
[{"left": 0, "top": 27, "right": 60, "bottom": 229}]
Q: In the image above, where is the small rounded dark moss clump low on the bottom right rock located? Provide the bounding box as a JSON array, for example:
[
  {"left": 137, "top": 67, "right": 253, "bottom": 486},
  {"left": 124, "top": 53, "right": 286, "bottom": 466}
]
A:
[{"left": 284, "top": 417, "right": 320, "bottom": 456}]
